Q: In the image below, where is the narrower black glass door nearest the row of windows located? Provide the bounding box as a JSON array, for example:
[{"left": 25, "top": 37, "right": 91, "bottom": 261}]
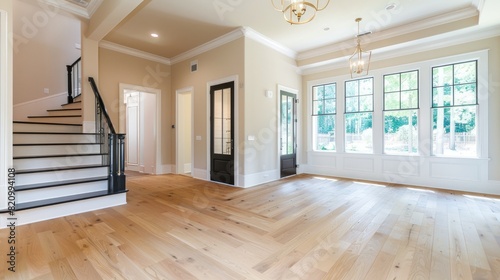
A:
[{"left": 280, "top": 91, "right": 297, "bottom": 178}]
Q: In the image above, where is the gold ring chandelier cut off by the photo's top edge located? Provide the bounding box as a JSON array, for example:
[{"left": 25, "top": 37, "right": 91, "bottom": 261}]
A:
[{"left": 271, "top": 0, "right": 330, "bottom": 24}]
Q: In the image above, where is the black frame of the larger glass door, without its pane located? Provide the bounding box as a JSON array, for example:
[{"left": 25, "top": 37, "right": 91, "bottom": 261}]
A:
[{"left": 209, "top": 81, "right": 236, "bottom": 185}]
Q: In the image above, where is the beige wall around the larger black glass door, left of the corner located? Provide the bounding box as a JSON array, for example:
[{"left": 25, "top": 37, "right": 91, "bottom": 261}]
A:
[{"left": 168, "top": 38, "right": 245, "bottom": 170}]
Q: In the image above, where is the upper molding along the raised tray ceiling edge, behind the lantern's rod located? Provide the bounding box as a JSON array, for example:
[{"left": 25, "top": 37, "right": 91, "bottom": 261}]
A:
[{"left": 297, "top": 7, "right": 479, "bottom": 61}]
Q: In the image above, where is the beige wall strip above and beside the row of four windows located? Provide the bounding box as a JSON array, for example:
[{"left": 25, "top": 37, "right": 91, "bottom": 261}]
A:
[{"left": 302, "top": 37, "right": 500, "bottom": 180}]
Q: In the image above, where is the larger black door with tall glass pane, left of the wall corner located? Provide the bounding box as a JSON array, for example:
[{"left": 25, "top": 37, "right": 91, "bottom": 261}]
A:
[{"left": 210, "top": 82, "right": 234, "bottom": 185}]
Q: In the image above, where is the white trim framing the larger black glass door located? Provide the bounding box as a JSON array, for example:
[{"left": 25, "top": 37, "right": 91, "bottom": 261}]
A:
[{"left": 205, "top": 75, "right": 241, "bottom": 187}]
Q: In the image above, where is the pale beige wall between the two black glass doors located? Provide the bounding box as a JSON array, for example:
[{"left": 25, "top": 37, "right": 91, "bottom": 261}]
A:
[{"left": 240, "top": 39, "right": 301, "bottom": 175}]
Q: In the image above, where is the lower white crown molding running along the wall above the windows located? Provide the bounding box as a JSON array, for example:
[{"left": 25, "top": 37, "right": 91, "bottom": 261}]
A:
[{"left": 299, "top": 25, "right": 500, "bottom": 75}]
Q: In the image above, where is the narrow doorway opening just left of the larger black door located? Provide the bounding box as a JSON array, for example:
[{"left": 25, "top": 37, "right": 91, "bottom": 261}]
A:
[{"left": 175, "top": 88, "right": 194, "bottom": 176}]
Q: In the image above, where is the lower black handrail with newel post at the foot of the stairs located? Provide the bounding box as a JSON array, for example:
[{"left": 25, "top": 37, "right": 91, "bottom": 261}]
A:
[{"left": 89, "top": 77, "right": 126, "bottom": 194}]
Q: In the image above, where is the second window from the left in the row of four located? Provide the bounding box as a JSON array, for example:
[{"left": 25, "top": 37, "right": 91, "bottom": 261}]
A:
[{"left": 345, "top": 78, "right": 373, "bottom": 153}]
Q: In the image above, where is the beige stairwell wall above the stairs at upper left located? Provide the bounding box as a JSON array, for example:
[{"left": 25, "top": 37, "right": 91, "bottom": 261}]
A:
[{"left": 13, "top": 0, "right": 80, "bottom": 104}]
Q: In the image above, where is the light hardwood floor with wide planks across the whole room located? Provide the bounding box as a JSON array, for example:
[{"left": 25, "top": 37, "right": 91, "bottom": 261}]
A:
[{"left": 0, "top": 175, "right": 500, "bottom": 280}]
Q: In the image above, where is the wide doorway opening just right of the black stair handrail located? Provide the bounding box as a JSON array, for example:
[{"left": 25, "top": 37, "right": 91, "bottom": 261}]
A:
[{"left": 119, "top": 84, "right": 161, "bottom": 174}]
